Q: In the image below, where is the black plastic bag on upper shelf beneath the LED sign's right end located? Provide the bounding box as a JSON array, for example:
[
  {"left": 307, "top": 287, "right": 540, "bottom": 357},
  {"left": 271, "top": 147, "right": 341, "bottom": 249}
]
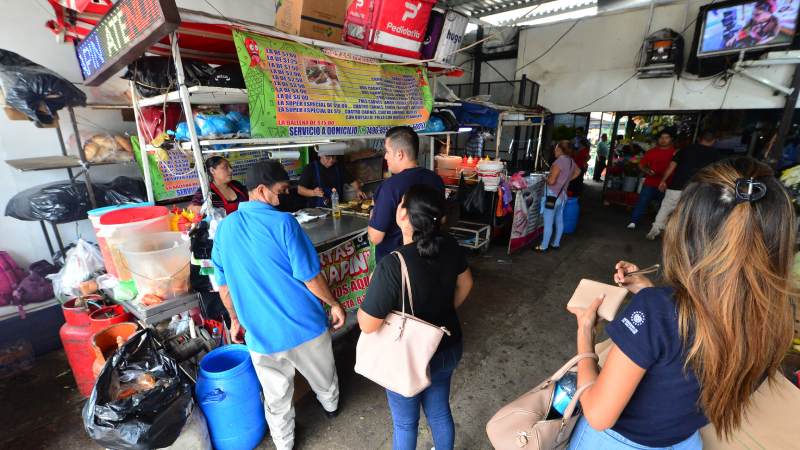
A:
[{"left": 122, "top": 56, "right": 214, "bottom": 97}]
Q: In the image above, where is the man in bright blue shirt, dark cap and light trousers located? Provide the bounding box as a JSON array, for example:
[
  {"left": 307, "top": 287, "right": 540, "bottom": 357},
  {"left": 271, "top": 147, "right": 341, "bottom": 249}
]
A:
[{"left": 211, "top": 161, "right": 345, "bottom": 450}]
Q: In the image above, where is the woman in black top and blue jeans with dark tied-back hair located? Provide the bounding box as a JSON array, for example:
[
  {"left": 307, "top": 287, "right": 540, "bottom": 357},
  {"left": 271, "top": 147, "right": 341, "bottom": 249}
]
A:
[{"left": 358, "top": 184, "right": 472, "bottom": 450}]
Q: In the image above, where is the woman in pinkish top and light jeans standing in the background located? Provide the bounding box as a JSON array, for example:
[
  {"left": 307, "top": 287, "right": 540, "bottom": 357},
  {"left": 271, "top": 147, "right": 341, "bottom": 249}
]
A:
[{"left": 534, "top": 140, "right": 581, "bottom": 252}]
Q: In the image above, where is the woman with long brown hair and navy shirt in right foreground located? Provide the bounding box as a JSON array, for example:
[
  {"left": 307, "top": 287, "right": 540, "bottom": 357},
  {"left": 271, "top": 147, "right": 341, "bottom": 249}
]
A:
[{"left": 570, "top": 158, "right": 797, "bottom": 449}]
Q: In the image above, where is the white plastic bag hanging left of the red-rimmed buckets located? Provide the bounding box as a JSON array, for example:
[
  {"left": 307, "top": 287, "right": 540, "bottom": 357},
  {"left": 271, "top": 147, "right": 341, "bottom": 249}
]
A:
[{"left": 47, "top": 239, "right": 105, "bottom": 298}]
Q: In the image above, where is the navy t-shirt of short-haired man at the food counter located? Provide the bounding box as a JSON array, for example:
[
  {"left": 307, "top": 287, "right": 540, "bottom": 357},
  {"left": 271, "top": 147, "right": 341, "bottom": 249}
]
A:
[{"left": 369, "top": 167, "right": 444, "bottom": 262}]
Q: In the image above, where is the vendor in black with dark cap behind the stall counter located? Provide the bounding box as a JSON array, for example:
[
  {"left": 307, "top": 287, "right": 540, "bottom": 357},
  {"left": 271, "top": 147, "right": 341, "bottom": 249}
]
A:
[{"left": 297, "top": 155, "right": 366, "bottom": 207}]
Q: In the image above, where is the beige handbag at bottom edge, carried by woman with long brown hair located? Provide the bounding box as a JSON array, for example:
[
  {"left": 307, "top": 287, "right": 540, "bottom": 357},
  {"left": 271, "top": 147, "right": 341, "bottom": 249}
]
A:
[{"left": 486, "top": 353, "right": 597, "bottom": 450}]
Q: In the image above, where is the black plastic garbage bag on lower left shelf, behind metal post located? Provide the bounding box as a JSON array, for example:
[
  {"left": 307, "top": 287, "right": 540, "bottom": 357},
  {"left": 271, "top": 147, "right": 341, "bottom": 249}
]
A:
[{"left": 5, "top": 177, "right": 147, "bottom": 223}]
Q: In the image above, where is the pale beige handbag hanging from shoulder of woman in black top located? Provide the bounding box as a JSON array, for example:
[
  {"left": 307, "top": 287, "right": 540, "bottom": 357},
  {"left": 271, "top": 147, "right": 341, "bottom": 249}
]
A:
[{"left": 355, "top": 252, "right": 450, "bottom": 397}]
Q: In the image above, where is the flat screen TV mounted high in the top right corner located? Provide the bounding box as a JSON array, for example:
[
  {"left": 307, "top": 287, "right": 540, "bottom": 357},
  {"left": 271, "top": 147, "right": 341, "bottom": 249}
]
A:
[{"left": 697, "top": 0, "right": 800, "bottom": 58}]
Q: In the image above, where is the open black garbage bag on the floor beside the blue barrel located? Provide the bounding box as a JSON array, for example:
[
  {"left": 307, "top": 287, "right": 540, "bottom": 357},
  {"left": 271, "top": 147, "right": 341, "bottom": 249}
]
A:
[{"left": 82, "top": 329, "right": 194, "bottom": 450}]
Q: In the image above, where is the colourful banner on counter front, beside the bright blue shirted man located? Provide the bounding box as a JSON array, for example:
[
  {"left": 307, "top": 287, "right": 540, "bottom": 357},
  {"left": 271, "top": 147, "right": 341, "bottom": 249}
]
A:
[{"left": 319, "top": 232, "right": 375, "bottom": 312}]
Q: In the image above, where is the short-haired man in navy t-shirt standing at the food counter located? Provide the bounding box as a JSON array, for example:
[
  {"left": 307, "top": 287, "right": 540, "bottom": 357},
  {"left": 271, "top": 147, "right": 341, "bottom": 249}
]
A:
[{"left": 368, "top": 127, "right": 444, "bottom": 262}]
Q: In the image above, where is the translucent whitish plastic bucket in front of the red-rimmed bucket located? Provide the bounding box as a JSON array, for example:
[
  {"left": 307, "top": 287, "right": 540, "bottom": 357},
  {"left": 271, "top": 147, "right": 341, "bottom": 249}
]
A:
[{"left": 120, "top": 231, "right": 191, "bottom": 299}]
